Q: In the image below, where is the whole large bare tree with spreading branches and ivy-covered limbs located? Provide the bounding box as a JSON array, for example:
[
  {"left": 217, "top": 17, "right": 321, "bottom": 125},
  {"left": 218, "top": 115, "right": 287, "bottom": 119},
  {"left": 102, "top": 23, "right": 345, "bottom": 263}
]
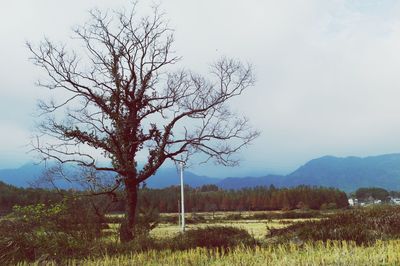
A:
[{"left": 27, "top": 3, "right": 259, "bottom": 240}]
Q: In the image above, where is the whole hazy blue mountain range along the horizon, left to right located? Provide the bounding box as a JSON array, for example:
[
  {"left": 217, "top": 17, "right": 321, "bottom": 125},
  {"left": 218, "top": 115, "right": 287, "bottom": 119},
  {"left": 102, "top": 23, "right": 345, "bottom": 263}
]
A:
[{"left": 0, "top": 154, "right": 400, "bottom": 192}]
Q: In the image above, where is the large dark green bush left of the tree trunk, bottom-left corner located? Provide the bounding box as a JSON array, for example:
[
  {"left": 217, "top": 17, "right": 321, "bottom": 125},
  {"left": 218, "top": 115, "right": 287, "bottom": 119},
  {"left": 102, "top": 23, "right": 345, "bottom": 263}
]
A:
[{"left": 0, "top": 196, "right": 102, "bottom": 264}]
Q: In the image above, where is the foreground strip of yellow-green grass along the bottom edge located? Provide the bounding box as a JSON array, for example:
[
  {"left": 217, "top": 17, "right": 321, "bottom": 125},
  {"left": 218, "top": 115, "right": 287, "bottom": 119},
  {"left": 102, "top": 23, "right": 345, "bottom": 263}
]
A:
[{"left": 18, "top": 240, "right": 400, "bottom": 266}]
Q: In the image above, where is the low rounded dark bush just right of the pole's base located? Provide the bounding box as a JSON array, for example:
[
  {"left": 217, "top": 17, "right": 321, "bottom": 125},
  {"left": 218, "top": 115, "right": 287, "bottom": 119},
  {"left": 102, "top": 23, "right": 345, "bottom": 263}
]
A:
[{"left": 171, "top": 226, "right": 257, "bottom": 250}]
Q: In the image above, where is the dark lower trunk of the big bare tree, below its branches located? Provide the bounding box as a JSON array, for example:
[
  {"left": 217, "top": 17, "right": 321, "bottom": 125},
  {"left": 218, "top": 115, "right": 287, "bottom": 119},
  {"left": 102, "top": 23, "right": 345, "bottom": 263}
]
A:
[{"left": 120, "top": 178, "right": 138, "bottom": 242}]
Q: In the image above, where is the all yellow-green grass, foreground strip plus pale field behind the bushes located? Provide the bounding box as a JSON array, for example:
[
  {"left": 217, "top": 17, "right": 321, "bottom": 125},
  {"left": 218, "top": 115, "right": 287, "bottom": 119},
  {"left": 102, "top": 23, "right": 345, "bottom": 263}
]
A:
[{"left": 12, "top": 209, "right": 400, "bottom": 266}]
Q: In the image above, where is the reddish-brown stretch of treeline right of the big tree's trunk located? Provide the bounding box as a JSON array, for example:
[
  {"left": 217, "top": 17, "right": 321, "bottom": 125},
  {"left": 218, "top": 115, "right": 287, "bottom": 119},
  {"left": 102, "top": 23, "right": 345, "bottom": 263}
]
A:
[{"left": 133, "top": 185, "right": 348, "bottom": 212}]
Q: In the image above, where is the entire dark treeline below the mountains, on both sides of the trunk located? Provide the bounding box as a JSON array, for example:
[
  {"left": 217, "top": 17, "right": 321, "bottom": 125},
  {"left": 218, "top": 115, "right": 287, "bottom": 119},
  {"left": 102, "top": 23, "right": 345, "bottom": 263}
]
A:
[{"left": 0, "top": 182, "right": 348, "bottom": 213}]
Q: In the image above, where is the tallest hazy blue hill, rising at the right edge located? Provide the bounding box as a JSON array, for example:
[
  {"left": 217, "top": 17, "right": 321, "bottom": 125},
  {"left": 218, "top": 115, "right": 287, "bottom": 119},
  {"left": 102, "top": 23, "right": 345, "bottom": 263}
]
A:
[{"left": 285, "top": 154, "right": 400, "bottom": 191}]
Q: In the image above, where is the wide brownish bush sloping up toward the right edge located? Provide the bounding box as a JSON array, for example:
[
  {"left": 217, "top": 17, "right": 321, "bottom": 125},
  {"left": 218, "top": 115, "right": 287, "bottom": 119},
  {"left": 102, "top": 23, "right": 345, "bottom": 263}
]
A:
[{"left": 269, "top": 206, "right": 400, "bottom": 244}]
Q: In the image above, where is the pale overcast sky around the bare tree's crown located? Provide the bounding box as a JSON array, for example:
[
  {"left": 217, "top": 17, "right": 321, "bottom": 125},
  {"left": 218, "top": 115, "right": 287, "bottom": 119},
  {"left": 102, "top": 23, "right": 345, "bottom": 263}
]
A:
[{"left": 0, "top": 0, "right": 400, "bottom": 176}]
